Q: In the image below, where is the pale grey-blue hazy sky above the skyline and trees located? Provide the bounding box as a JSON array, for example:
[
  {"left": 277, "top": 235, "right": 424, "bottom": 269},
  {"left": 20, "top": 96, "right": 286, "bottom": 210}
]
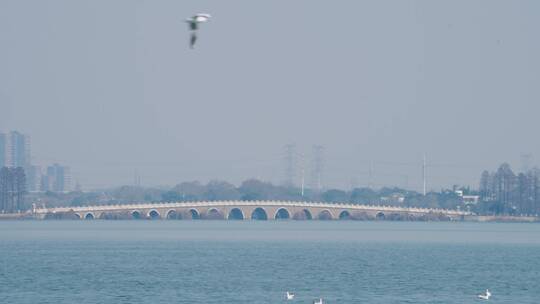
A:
[{"left": 0, "top": 0, "right": 540, "bottom": 189}]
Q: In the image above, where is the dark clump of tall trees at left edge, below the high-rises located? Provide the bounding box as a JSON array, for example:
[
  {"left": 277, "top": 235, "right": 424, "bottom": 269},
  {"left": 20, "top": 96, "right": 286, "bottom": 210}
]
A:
[{"left": 0, "top": 167, "right": 26, "bottom": 213}]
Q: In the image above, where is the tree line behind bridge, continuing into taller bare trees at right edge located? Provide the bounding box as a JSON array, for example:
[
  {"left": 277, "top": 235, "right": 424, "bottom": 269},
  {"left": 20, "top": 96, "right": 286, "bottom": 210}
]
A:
[{"left": 25, "top": 164, "right": 540, "bottom": 215}]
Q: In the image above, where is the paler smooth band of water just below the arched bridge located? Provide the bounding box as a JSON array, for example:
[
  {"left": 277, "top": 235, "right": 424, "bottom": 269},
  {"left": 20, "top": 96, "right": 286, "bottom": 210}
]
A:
[{"left": 0, "top": 220, "right": 540, "bottom": 244}]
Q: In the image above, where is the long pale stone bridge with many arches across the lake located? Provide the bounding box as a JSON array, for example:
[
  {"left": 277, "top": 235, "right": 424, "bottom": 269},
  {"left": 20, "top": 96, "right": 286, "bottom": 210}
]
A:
[{"left": 32, "top": 201, "right": 472, "bottom": 220}]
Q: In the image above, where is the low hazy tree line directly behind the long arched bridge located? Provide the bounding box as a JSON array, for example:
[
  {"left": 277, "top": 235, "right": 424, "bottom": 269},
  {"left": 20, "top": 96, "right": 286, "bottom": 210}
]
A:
[{"left": 38, "top": 179, "right": 470, "bottom": 213}]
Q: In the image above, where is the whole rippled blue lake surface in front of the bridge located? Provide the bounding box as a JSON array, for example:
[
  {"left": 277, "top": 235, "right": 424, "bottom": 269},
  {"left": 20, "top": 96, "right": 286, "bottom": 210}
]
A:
[{"left": 0, "top": 221, "right": 540, "bottom": 304}]
